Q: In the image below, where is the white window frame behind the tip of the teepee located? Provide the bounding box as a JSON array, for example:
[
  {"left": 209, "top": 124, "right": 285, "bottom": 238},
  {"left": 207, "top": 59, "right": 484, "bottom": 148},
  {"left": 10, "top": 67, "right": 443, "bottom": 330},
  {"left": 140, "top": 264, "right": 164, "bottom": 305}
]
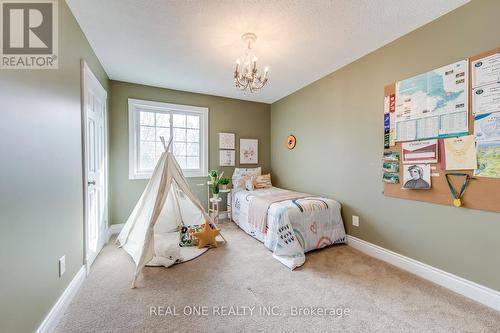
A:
[{"left": 128, "top": 98, "right": 208, "bottom": 179}]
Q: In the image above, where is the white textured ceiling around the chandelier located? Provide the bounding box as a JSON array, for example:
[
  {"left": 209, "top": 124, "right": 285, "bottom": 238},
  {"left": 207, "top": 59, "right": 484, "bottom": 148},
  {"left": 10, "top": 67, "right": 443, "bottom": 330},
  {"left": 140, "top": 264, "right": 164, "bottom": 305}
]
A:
[{"left": 67, "top": 0, "right": 468, "bottom": 103}]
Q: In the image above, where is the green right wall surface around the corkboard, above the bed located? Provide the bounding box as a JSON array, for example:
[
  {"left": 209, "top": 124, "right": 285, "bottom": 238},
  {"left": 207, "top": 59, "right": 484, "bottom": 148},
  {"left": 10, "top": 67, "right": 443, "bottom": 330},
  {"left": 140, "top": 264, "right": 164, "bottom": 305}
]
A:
[{"left": 271, "top": 0, "right": 500, "bottom": 290}]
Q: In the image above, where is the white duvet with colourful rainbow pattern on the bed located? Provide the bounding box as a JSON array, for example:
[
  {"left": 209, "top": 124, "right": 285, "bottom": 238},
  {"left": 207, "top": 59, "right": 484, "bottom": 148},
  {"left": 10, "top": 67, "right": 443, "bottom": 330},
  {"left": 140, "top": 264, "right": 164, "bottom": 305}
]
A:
[{"left": 231, "top": 187, "right": 346, "bottom": 269}]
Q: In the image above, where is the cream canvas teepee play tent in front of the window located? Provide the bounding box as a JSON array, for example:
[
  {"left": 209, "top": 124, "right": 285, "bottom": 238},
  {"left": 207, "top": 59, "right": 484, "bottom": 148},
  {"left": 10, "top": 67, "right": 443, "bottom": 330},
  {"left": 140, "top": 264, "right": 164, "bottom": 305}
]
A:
[{"left": 117, "top": 138, "right": 221, "bottom": 287}]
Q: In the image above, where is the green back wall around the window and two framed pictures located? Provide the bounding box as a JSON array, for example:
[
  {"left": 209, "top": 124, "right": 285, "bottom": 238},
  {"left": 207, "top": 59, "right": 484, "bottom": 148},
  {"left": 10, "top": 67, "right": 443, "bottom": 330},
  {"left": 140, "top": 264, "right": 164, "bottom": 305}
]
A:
[{"left": 109, "top": 81, "right": 271, "bottom": 224}]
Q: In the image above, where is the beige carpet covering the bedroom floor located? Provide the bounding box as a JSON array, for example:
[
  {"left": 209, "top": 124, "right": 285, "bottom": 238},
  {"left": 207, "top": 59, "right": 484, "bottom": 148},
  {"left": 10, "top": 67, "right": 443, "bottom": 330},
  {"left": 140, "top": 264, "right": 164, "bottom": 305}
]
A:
[{"left": 57, "top": 222, "right": 500, "bottom": 332}]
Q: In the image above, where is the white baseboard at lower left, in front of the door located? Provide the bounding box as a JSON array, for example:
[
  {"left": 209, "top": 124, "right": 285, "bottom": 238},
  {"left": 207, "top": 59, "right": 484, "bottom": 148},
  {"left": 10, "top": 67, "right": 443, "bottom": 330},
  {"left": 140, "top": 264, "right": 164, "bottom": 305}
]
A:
[{"left": 36, "top": 266, "right": 86, "bottom": 333}]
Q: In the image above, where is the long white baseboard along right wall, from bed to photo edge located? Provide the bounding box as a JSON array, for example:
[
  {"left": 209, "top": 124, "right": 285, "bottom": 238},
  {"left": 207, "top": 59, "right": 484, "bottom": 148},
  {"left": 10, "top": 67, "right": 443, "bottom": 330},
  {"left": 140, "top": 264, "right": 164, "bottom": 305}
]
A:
[{"left": 347, "top": 235, "right": 500, "bottom": 311}]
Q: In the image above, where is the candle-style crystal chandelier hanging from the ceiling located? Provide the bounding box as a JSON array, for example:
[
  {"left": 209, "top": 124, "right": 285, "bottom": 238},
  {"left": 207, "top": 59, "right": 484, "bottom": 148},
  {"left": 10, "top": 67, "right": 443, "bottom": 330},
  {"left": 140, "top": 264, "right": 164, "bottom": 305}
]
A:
[{"left": 234, "top": 32, "right": 269, "bottom": 93}]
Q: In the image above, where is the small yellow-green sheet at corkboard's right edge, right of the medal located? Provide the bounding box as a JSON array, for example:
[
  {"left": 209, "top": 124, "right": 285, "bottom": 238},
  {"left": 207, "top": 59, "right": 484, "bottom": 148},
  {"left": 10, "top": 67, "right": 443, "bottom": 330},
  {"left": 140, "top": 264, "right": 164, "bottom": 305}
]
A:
[{"left": 474, "top": 141, "right": 500, "bottom": 178}]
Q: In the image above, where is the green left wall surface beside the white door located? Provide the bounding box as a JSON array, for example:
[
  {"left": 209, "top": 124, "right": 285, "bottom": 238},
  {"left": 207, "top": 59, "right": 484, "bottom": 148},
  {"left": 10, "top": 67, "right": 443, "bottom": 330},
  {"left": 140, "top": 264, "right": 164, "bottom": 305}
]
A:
[{"left": 0, "top": 1, "right": 108, "bottom": 332}]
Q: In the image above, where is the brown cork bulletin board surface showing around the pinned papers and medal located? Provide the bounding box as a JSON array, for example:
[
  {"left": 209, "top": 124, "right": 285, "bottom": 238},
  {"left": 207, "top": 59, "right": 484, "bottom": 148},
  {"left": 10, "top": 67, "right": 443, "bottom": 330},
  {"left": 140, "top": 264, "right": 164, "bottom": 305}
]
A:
[{"left": 384, "top": 47, "right": 500, "bottom": 212}]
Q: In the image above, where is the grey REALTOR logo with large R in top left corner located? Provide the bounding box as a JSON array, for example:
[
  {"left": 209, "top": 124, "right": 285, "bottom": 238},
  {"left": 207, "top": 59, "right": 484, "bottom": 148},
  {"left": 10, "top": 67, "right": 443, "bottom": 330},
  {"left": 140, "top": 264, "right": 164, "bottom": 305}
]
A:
[{"left": 0, "top": 0, "right": 58, "bottom": 69}]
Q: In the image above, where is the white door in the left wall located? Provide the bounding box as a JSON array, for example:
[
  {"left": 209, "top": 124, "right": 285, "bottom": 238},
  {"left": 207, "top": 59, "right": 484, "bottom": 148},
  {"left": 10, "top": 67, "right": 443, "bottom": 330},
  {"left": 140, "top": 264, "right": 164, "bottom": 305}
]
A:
[{"left": 82, "top": 62, "right": 108, "bottom": 272}]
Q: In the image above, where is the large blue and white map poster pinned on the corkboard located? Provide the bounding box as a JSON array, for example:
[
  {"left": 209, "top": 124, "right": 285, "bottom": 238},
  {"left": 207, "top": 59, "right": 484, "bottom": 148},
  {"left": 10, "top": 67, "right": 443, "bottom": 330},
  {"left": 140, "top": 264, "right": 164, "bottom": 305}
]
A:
[{"left": 395, "top": 60, "right": 469, "bottom": 141}]
